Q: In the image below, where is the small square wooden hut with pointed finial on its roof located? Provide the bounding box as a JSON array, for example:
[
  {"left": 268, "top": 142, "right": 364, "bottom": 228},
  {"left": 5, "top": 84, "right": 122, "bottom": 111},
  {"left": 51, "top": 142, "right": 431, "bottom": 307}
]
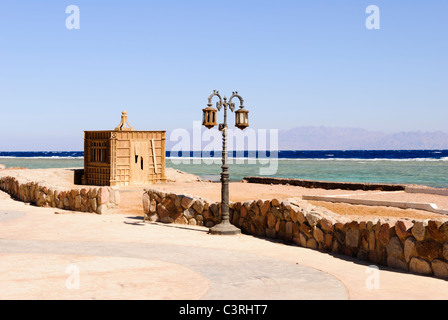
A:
[{"left": 83, "top": 111, "right": 166, "bottom": 186}]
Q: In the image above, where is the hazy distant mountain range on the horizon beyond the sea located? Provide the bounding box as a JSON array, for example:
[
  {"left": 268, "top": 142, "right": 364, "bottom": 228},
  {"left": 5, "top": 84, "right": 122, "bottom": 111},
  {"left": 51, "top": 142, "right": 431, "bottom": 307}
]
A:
[{"left": 167, "top": 126, "right": 448, "bottom": 150}]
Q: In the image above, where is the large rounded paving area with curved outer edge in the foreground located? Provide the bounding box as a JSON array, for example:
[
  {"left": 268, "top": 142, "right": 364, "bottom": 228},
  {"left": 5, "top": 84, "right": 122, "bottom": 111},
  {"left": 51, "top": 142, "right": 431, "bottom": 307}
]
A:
[{"left": 0, "top": 240, "right": 348, "bottom": 300}]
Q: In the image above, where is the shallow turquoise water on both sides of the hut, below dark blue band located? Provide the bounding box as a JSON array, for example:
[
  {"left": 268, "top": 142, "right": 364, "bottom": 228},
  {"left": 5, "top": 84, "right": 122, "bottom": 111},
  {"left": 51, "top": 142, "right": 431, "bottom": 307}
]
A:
[{"left": 0, "top": 158, "right": 448, "bottom": 188}]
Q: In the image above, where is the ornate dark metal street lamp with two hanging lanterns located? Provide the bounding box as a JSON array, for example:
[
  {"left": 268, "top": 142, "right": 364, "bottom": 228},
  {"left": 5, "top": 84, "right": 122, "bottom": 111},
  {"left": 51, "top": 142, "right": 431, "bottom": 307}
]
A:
[{"left": 202, "top": 90, "right": 249, "bottom": 235}]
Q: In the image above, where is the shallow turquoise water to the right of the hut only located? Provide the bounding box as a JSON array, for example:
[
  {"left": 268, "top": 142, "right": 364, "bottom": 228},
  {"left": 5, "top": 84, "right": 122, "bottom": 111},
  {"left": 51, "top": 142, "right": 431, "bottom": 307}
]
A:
[{"left": 167, "top": 159, "right": 448, "bottom": 188}]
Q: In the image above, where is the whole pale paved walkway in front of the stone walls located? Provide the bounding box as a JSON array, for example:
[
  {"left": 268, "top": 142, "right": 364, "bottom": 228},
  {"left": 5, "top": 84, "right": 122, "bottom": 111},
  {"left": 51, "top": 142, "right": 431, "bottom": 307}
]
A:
[{"left": 0, "top": 193, "right": 448, "bottom": 300}]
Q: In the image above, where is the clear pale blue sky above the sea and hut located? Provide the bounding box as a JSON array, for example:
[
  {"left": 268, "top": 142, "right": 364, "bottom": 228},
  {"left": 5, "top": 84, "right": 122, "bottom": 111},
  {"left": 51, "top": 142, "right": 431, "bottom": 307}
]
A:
[{"left": 0, "top": 0, "right": 448, "bottom": 151}]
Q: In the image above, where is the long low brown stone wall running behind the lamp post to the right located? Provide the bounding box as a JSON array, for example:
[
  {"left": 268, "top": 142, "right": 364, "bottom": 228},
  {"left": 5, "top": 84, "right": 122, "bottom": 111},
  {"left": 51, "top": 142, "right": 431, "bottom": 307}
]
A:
[{"left": 143, "top": 189, "right": 448, "bottom": 279}]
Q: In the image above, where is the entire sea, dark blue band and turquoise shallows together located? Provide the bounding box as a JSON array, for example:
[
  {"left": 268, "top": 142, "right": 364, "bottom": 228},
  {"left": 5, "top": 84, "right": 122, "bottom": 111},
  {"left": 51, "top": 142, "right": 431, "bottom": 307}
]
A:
[{"left": 0, "top": 150, "right": 448, "bottom": 188}]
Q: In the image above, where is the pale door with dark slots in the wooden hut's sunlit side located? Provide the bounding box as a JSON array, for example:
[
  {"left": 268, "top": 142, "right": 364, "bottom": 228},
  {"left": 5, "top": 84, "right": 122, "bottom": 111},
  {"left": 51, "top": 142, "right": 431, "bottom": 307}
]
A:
[{"left": 130, "top": 141, "right": 154, "bottom": 185}]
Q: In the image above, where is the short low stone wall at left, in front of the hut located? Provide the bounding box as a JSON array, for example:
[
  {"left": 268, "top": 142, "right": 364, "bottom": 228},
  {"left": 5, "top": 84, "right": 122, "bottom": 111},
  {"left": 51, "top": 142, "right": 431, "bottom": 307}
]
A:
[{"left": 0, "top": 176, "right": 120, "bottom": 214}]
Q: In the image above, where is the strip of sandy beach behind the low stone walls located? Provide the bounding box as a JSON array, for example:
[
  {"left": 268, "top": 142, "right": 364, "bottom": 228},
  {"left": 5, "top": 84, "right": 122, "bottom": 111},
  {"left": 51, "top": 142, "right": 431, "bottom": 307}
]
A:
[{"left": 0, "top": 168, "right": 448, "bottom": 219}]
